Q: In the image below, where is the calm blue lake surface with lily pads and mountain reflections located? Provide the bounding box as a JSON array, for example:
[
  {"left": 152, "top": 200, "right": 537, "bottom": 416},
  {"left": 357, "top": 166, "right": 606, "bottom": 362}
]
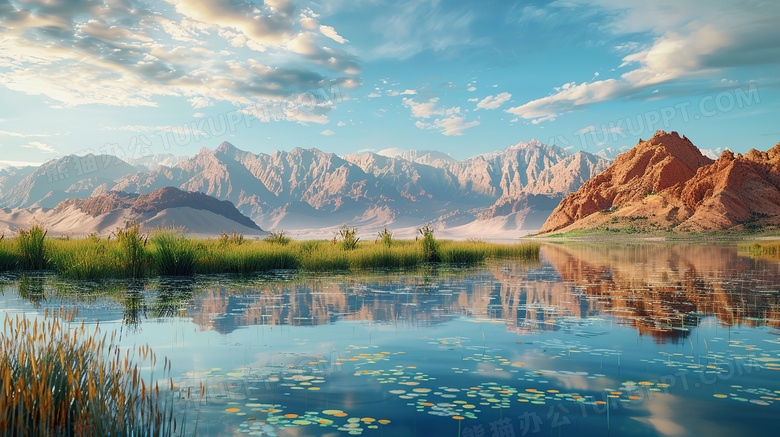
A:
[{"left": 0, "top": 244, "right": 780, "bottom": 437}]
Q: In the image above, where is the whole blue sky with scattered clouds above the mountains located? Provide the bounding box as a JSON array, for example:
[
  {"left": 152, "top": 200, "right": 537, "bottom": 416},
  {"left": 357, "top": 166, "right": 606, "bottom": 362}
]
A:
[{"left": 0, "top": 0, "right": 780, "bottom": 165}]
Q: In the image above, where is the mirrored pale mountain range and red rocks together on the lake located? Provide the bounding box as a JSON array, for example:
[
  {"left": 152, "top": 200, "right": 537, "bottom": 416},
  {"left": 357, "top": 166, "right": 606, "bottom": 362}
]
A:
[{"left": 180, "top": 244, "right": 780, "bottom": 342}]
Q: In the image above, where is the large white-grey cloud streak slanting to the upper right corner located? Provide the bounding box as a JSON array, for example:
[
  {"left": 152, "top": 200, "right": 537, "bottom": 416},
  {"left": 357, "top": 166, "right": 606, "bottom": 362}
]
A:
[{"left": 507, "top": 0, "right": 780, "bottom": 119}]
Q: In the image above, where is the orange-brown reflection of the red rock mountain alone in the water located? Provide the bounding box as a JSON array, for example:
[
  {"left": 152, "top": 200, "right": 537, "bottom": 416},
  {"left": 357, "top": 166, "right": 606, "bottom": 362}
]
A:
[{"left": 543, "top": 244, "right": 780, "bottom": 342}]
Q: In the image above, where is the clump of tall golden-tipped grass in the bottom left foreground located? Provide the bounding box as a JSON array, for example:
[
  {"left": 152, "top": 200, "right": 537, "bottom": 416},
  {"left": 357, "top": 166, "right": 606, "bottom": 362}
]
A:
[{"left": 0, "top": 315, "right": 185, "bottom": 436}]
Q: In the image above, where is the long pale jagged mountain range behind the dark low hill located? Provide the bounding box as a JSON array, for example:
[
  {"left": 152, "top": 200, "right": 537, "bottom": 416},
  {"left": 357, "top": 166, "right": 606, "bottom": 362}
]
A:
[{"left": 0, "top": 140, "right": 609, "bottom": 237}]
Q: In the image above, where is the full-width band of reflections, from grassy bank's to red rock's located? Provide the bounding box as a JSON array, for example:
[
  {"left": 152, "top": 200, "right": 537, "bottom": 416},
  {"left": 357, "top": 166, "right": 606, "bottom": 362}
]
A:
[{"left": 7, "top": 243, "right": 780, "bottom": 343}]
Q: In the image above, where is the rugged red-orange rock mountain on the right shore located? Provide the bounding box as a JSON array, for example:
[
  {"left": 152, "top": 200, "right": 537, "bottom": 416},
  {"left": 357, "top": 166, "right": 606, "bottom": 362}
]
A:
[{"left": 540, "top": 131, "right": 780, "bottom": 233}]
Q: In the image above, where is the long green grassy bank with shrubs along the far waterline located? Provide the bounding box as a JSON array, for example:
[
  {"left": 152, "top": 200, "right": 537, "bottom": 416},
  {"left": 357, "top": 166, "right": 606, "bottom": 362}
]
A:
[{"left": 0, "top": 226, "right": 540, "bottom": 279}]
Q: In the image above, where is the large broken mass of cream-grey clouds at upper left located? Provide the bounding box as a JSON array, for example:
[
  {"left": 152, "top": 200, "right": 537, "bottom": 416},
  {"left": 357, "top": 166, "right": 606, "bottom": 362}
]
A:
[{"left": 0, "top": 0, "right": 362, "bottom": 122}]
